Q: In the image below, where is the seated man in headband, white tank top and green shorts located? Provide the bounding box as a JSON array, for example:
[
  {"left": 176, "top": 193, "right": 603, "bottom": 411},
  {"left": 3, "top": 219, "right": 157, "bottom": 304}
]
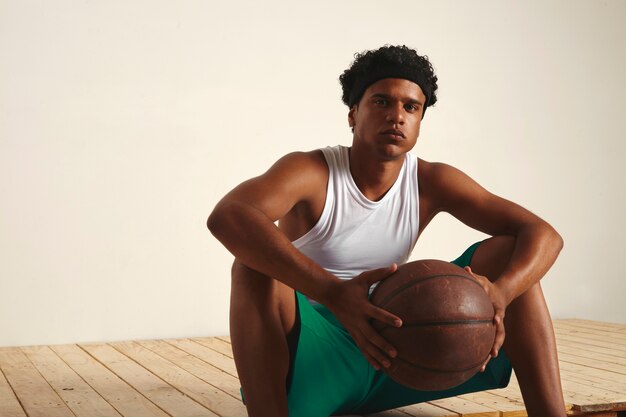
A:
[{"left": 207, "top": 46, "right": 565, "bottom": 417}]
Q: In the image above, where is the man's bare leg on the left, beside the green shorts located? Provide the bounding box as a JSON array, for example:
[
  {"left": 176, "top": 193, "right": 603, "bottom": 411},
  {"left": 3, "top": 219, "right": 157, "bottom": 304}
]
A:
[{"left": 230, "top": 261, "right": 296, "bottom": 417}]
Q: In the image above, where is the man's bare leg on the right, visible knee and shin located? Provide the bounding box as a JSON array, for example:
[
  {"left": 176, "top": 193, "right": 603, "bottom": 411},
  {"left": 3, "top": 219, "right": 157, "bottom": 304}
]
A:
[{"left": 470, "top": 236, "right": 566, "bottom": 417}]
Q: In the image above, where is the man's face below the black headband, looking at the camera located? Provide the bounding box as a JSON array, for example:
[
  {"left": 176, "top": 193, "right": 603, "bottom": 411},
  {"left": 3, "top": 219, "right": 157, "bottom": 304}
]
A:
[{"left": 348, "top": 78, "right": 426, "bottom": 160}]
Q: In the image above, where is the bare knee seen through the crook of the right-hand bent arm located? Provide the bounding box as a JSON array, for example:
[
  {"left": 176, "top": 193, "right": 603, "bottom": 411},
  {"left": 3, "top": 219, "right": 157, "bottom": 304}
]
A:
[{"left": 470, "top": 236, "right": 515, "bottom": 281}]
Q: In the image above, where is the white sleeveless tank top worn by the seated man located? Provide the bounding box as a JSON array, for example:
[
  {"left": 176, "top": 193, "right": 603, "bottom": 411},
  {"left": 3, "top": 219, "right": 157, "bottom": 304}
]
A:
[{"left": 293, "top": 146, "right": 419, "bottom": 290}]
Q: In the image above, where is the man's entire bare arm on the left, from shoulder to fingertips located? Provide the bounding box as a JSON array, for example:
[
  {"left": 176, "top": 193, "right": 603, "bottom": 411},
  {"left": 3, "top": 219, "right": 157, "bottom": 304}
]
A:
[{"left": 207, "top": 153, "right": 401, "bottom": 368}]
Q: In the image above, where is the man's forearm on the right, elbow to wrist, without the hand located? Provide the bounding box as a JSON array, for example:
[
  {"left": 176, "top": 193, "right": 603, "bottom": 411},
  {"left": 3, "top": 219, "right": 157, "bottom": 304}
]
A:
[{"left": 495, "top": 221, "right": 563, "bottom": 305}]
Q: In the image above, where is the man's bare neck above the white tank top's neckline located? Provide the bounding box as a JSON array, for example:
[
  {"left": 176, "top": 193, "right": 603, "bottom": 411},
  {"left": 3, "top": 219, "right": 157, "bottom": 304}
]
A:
[{"left": 349, "top": 146, "right": 404, "bottom": 201}]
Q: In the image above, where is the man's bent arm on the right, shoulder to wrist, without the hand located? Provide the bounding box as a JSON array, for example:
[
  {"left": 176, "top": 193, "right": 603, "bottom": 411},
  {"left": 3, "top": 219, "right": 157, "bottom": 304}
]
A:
[{"left": 419, "top": 161, "right": 563, "bottom": 305}]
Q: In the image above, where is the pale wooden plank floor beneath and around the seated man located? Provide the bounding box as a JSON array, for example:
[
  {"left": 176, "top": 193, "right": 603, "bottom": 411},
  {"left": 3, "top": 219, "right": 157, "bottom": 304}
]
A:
[{"left": 0, "top": 320, "right": 626, "bottom": 417}]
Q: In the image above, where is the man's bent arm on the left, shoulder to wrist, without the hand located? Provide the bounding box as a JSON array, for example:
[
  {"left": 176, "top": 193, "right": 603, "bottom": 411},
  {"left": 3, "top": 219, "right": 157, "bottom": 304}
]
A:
[{"left": 207, "top": 153, "right": 338, "bottom": 303}]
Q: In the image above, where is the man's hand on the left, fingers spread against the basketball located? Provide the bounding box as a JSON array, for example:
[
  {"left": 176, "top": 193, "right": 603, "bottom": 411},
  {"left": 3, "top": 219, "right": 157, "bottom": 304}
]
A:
[{"left": 326, "top": 264, "right": 402, "bottom": 370}]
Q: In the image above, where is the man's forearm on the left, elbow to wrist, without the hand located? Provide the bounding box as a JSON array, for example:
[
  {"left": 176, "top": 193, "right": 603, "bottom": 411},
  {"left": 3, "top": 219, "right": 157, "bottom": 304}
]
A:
[{"left": 207, "top": 202, "right": 339, "bottom": 304}]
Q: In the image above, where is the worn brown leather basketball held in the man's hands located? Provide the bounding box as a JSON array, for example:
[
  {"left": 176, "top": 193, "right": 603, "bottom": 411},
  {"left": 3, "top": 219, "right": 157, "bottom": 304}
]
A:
[{"left": 372, "top": 260, "right": 495, "bottom": 391}]
